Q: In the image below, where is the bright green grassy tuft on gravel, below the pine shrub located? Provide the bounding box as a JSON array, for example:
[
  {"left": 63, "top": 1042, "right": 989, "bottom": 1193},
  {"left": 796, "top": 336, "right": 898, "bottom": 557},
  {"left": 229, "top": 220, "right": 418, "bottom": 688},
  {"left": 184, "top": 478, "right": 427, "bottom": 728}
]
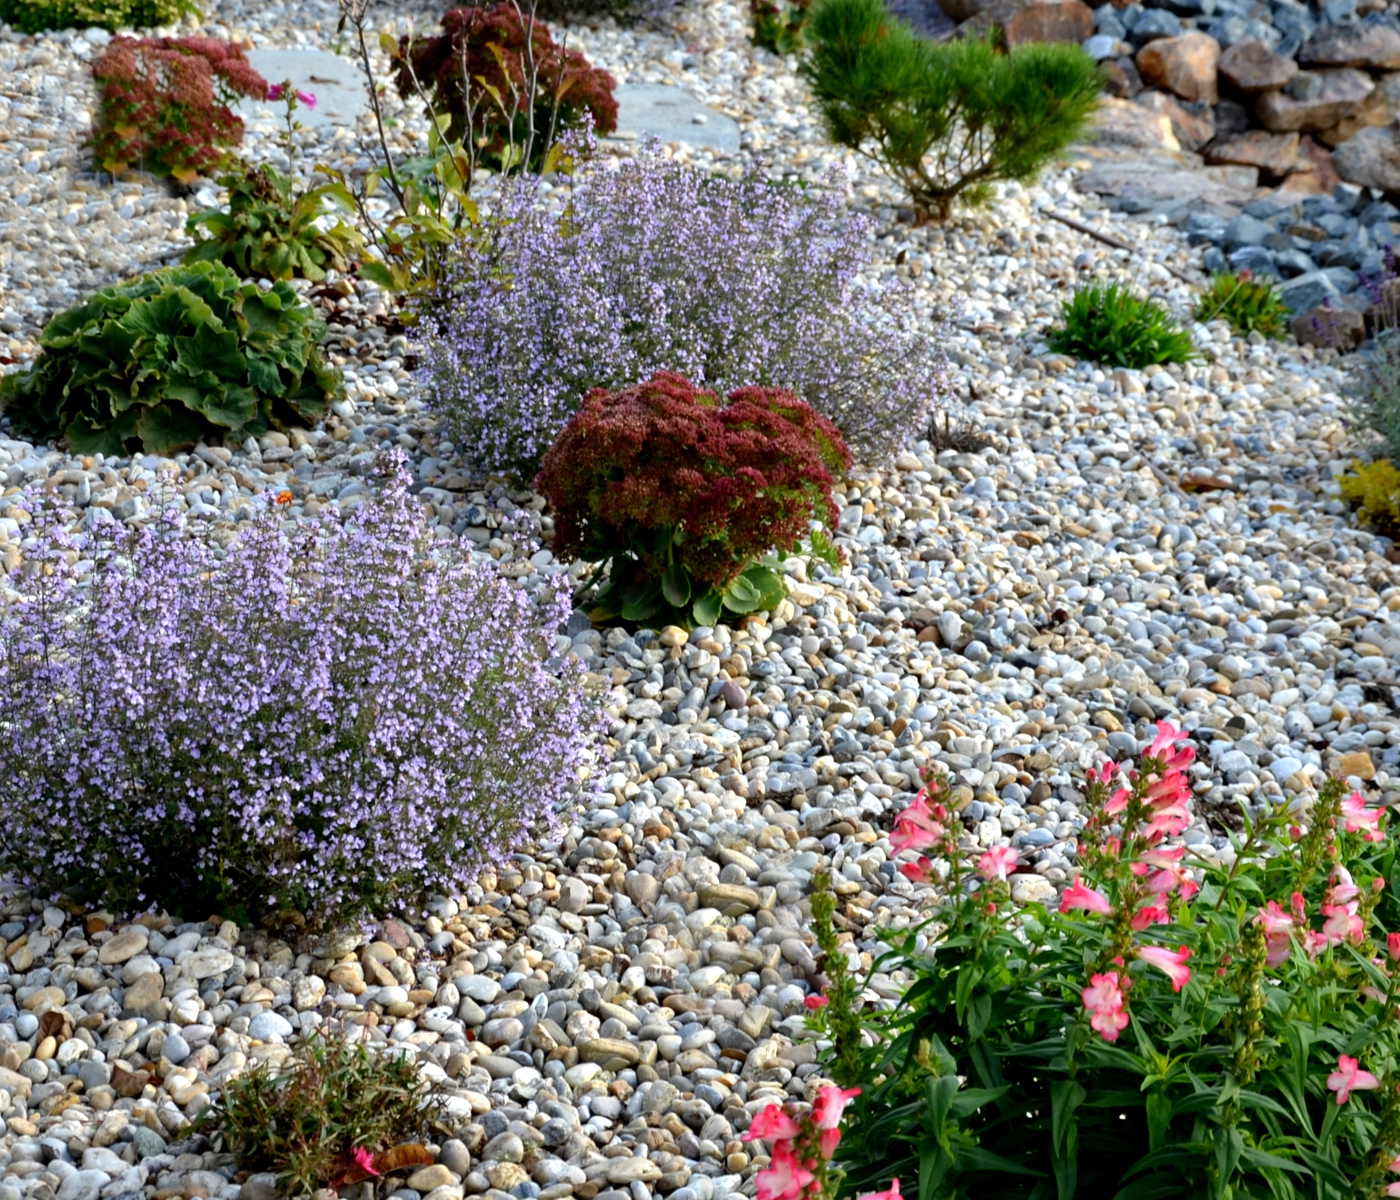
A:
[{"left": 1046, "top": 283, "right": 1196, "bottom": 370}]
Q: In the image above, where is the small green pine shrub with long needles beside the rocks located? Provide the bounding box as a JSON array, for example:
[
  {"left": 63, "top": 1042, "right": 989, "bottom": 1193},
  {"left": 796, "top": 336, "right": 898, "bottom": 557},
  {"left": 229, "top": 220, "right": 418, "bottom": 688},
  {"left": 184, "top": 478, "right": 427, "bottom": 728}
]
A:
[{"left": 804, "top": 0, "right": 1102, "bottom": 220}]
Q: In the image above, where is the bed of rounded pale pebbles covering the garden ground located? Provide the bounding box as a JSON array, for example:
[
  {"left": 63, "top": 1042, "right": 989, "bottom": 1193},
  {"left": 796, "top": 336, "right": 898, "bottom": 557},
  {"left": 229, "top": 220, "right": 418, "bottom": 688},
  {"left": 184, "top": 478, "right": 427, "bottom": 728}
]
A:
[{"left": 0, "top": 3, "right": 1400, "bottom": 1200}]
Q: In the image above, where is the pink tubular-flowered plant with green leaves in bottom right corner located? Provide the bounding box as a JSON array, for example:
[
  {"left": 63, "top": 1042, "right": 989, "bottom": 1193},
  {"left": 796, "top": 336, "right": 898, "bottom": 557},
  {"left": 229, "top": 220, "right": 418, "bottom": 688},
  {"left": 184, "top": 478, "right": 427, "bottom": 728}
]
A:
[{"left": 808, "top": 724, "right": 1400, "bottom": 1200}]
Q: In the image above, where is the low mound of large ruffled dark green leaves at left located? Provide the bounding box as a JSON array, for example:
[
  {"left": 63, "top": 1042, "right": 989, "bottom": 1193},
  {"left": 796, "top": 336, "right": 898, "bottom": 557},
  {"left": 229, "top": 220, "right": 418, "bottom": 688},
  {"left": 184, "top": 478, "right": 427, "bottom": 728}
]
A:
[{"left": 0, "top": 262, "right": 340, "bottom": 455}]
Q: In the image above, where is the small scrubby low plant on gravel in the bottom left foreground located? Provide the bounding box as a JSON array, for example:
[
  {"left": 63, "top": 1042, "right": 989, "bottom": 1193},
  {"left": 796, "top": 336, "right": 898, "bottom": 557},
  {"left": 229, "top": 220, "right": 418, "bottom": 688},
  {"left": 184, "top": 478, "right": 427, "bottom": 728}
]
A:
[{"left": 200, "top": 1026, "right": 440, "bottom": 1196}]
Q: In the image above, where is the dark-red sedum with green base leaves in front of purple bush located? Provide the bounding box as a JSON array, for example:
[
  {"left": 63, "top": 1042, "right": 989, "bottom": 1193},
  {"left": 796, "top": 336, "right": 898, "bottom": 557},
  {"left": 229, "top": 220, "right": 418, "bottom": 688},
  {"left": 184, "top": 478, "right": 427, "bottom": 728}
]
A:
[{"left": 536, "top": 371, "right": 851, "bottom": 627}]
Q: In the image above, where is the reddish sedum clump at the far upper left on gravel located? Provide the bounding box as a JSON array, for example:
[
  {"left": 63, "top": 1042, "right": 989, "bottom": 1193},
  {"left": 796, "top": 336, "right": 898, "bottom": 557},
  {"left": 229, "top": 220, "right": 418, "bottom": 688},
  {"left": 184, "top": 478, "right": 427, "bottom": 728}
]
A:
[{"left": 92, "top": 38, "right": 267, "bottom": 183}]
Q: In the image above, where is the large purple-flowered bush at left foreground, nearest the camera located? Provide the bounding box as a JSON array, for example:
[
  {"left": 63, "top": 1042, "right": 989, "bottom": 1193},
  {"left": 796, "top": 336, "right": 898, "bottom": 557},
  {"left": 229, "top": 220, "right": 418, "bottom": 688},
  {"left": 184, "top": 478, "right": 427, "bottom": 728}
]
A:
[{"left": 0, "top": 461, "right": 598, "bottom": 924}]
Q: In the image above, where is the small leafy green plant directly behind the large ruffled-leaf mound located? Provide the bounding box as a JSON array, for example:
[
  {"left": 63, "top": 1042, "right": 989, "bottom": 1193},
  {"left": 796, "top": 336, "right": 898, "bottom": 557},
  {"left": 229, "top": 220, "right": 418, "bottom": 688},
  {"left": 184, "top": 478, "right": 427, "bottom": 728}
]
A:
[{"left": 182, "top": 165, "right": 364, "bottom": 283}]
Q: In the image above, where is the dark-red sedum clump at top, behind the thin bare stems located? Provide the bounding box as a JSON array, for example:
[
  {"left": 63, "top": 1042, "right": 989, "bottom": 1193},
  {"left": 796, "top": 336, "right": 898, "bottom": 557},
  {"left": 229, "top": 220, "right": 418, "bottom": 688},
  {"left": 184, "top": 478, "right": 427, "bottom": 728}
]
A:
[{"left": 386, "top": 3, "right": 617, "bottom": 171}]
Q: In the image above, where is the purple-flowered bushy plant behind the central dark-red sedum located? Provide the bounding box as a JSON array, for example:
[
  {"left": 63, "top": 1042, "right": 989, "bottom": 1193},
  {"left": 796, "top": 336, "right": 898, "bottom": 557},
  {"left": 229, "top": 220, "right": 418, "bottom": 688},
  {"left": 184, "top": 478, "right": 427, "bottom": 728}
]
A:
[{"left": 421, "top": 147, "right": 946, "bottom": 479}]
